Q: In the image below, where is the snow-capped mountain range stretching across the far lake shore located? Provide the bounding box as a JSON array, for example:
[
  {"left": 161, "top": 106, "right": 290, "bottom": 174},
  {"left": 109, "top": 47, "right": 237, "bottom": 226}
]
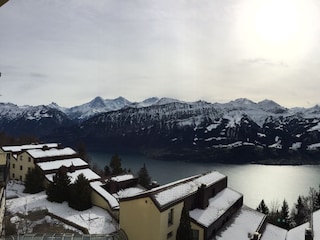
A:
[{"left": 0, "top": 97, "right": 320, "bottom": 164}]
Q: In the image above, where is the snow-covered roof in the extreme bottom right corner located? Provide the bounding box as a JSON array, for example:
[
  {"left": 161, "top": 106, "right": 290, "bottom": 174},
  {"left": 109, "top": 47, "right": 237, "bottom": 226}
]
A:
[{"left": 286, "top": 210, "right": 320, "bottom": 240}]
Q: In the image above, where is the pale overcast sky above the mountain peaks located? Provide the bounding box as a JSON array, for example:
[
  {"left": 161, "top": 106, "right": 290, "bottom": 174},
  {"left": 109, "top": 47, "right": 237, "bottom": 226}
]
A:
[{"left": 0, "top": 0, "right": 320, "bottom": 107}]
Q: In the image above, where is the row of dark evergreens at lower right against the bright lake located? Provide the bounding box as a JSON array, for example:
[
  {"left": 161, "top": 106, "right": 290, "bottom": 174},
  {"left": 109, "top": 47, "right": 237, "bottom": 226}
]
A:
[{"left": 257, "top": 186, "right": 320, "bottom": 230}]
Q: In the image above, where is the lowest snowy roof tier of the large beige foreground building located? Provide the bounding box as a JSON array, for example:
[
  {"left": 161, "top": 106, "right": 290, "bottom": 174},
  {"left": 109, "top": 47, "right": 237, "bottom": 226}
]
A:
[{"left": 214, "top": 206, "right": 264, "bottom": 240}]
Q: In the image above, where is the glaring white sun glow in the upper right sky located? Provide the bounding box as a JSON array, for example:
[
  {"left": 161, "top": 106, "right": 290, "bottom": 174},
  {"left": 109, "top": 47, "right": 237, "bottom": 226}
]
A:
[{"left": 236, "top": 0, "right": 320, "bottom": 62}]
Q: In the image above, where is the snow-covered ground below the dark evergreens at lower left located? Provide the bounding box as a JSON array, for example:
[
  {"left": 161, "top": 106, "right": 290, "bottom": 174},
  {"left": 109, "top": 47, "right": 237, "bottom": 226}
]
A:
[{"left": 6, "top": 181, "right": 118, "bottom": 234}]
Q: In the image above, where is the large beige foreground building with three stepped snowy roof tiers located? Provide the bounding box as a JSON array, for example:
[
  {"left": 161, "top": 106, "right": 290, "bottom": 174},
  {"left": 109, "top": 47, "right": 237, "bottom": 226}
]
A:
[{"left": 120, "top": 171, "right": 272, "bottom": 240}]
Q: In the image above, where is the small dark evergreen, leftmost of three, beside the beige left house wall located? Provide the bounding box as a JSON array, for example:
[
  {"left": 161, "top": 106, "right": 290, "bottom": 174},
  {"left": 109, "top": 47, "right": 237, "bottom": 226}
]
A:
[{"left": 24, "top": 167, "right": 44, "bottom": 194}]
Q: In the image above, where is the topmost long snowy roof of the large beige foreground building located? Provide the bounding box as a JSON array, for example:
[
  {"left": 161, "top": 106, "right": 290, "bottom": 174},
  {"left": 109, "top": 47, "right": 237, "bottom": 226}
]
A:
[{"left": 153, "top": 171, "right": 226, "bottom": 206}]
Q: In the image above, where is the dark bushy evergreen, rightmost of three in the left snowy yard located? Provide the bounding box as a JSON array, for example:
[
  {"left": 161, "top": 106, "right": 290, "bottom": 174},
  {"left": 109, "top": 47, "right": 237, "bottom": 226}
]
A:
[{"left": 69, "top": 174, "right": 92, "bottom": 211}]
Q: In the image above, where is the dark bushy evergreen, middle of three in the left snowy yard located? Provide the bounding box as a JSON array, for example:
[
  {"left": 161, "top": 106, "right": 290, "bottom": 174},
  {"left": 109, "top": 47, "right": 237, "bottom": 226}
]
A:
[{"left": 47, "top": 167, "right": 71, "bottom": 203}]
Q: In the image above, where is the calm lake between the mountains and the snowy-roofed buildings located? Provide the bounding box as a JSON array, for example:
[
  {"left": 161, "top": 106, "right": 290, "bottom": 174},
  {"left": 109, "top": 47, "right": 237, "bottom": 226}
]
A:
[{"left": 89, "top": 152, "right": 320, "bottom": 208}]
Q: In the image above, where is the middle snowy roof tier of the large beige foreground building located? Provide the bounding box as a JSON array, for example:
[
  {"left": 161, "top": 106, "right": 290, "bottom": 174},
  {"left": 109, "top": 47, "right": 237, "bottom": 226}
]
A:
[{"left": 189, "top": 188, "right": 242, "bottom": 227}]
